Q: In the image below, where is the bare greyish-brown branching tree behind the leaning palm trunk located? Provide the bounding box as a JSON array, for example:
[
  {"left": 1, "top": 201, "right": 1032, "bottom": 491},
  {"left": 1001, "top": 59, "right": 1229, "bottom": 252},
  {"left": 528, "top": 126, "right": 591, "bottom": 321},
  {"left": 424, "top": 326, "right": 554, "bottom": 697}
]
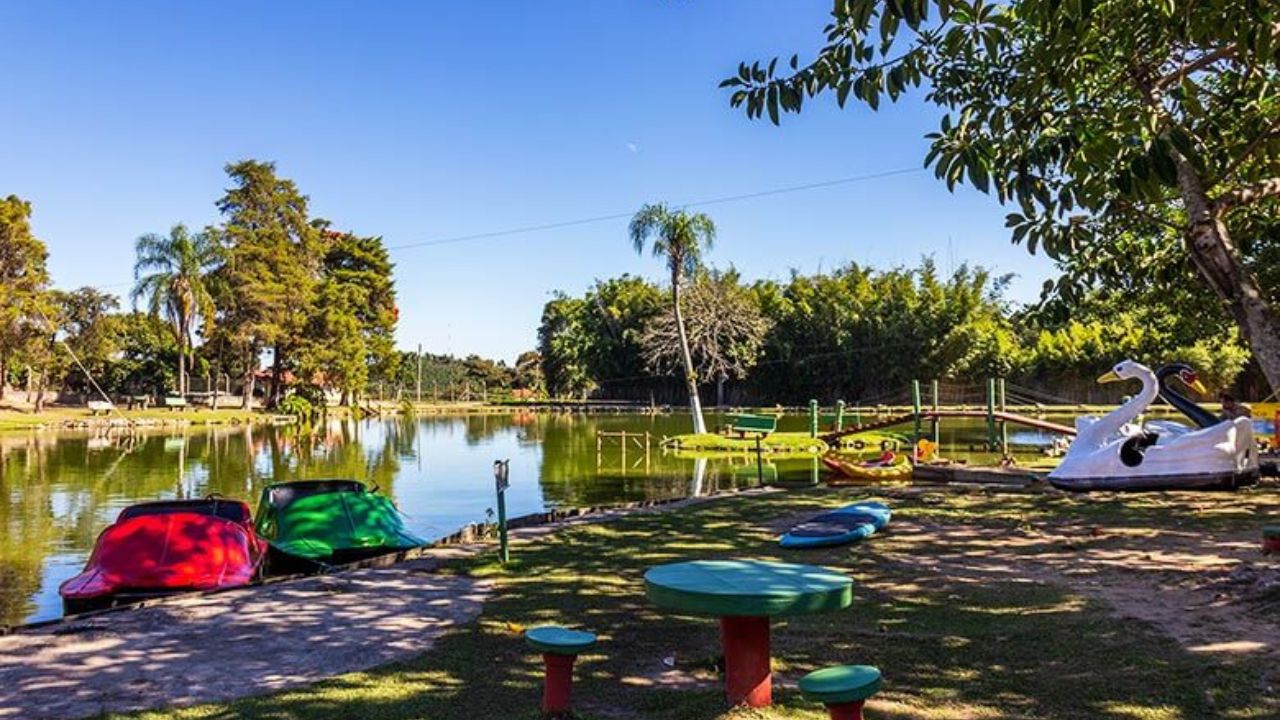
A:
[{"left": 641, "top": 270, "right": 769, "bottom": 406}]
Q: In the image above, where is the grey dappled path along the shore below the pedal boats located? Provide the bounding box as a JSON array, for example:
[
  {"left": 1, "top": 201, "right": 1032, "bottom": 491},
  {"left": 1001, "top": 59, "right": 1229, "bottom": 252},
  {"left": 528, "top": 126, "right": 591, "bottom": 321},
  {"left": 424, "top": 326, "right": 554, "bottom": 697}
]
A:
[{"left": 0, "top": 560, "right": 490, "bottom": 720}]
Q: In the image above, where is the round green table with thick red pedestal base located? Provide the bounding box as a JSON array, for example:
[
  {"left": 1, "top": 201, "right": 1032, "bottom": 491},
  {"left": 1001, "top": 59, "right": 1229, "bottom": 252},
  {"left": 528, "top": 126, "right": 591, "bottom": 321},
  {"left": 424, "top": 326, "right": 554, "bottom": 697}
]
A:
[{"left": 644, "top": 560, "right": 854, "bottom": 707}]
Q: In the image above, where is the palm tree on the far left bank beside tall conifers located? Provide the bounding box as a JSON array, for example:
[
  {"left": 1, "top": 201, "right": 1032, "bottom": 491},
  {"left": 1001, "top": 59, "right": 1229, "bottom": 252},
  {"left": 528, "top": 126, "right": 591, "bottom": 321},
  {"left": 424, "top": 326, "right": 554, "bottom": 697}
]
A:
[{"left": 129, "top": 223, "right": 221, "bottom": 395}]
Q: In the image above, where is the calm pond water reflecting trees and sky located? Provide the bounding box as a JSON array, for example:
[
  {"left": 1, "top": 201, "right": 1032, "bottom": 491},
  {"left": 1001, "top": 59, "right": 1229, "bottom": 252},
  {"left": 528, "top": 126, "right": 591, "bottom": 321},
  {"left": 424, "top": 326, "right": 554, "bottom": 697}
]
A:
[{"left": 0, "top": 414, "right": 1041, "bottom": 625}]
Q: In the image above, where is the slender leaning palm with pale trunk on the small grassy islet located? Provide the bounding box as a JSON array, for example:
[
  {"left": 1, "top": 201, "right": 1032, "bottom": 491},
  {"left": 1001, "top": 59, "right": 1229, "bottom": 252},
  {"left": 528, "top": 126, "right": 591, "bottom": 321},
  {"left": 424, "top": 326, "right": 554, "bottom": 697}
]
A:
[{"left": 628, "top": 202, "right": 716, "bottom": 433}]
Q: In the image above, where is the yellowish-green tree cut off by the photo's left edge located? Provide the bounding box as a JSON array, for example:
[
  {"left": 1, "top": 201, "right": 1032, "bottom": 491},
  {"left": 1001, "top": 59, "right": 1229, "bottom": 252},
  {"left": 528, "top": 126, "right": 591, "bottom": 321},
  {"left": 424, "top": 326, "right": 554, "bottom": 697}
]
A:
[{"left": 0, "top": 195, "right": 49, "bottom": 400}]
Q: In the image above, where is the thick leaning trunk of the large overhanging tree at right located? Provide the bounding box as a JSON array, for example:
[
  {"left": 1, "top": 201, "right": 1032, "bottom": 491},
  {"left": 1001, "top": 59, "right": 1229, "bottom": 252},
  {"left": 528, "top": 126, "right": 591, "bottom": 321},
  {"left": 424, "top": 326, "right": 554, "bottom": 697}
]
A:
[{"left": 1174, "top": 154, "right": 1280, "bottom": 389}]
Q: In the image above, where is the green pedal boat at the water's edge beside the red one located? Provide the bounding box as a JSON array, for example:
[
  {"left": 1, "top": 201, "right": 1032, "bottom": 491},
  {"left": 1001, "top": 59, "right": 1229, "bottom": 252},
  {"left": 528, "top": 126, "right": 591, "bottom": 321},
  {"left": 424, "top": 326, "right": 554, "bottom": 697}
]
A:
[{"left": 255, "top": 480, "right": 426, "bottom": 570}]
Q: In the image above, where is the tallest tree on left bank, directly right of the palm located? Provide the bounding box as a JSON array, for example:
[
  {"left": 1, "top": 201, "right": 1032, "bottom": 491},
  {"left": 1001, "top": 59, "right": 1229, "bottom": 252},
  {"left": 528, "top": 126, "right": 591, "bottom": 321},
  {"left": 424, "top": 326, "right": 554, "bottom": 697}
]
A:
[{"left": 218, "top": 160, "right": 321, "bottom": 409}]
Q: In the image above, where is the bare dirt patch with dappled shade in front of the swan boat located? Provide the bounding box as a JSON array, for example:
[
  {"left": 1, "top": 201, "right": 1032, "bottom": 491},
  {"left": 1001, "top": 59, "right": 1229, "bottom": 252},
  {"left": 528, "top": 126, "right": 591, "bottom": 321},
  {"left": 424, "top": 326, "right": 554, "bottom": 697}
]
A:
[{"left": 869, "top": 521, "right": 1280, "bottom": 660}]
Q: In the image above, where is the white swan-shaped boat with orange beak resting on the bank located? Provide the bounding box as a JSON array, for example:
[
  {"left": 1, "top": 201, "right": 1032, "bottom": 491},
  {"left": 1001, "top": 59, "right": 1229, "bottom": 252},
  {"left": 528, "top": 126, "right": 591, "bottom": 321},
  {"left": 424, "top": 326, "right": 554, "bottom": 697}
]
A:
[{"left": 1048, "top": 360, "right": 1258, "bottom": 491}]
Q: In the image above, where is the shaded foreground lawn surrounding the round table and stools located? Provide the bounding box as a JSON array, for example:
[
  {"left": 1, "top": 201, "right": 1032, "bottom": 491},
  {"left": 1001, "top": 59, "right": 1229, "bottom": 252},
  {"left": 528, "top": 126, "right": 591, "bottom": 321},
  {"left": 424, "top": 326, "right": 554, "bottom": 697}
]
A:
[{"left": 112, "top": 488, "right": 1280, "bottom": 720}]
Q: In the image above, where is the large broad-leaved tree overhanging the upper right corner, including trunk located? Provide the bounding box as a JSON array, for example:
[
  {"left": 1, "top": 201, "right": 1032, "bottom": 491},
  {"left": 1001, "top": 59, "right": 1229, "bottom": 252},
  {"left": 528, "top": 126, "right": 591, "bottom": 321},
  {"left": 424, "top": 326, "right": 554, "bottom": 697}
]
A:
[{"left": 722, "top": 0, "right": 1280, "bottom": 388}]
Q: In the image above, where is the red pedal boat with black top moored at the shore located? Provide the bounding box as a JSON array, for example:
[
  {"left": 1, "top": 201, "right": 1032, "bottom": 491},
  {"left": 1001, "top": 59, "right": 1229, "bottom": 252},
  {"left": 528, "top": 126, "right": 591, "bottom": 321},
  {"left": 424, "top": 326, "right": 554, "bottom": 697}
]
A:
[{"left": 58, "top": 497, "right": 266, "bottom": 615}]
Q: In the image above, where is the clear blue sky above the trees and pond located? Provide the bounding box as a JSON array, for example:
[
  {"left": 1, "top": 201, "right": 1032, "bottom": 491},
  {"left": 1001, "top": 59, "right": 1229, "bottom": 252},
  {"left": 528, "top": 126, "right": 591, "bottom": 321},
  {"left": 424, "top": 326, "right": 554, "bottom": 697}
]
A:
[{"left": 0, "top": 0, "right": 1052, "bottom": 360}]
